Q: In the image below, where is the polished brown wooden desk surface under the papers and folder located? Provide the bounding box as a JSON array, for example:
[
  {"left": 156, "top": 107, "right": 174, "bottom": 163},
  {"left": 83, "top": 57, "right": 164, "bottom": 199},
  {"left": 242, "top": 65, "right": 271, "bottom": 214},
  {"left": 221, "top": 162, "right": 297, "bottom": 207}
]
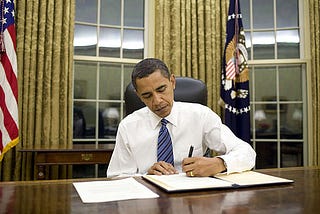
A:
[{"left": 0, "top": 167, "right": 320, "bottom": 214}]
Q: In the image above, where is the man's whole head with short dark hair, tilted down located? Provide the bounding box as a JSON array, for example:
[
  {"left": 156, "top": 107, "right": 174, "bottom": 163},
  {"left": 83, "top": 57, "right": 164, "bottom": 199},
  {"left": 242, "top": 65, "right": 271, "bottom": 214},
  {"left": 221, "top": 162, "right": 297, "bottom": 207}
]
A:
[{"left": 131, "top": 58, "right": 176, "bottom": 118}]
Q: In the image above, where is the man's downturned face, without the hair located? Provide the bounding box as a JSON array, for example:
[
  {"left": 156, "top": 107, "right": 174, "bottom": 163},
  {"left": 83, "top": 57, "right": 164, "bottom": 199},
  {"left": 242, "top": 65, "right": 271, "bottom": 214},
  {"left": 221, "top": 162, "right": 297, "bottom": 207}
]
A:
[{"left": 136, "top": 71, "right": 176, "bottom": 118}]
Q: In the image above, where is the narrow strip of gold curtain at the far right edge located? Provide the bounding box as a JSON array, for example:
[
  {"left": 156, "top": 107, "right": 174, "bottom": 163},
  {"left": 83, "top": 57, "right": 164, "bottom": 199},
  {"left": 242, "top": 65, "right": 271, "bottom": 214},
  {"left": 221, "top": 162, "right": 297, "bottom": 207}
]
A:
[{"left": 309, "top": 0, "right": 320, "bottom": 166}]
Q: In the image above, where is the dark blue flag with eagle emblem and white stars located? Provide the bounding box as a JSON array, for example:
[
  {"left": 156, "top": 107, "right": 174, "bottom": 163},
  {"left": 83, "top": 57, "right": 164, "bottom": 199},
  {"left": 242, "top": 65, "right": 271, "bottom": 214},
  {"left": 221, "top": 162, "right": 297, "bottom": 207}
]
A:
[{"left": 220, "top": 0, "right": 250, "bottom": 143}]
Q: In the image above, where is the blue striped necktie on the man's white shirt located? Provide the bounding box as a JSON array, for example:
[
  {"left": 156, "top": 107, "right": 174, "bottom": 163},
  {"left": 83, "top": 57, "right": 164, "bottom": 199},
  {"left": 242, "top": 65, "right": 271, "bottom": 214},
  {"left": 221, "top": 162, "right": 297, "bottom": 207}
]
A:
[{"left": 157, "top": 119, "right": 174, "bottom": 165}]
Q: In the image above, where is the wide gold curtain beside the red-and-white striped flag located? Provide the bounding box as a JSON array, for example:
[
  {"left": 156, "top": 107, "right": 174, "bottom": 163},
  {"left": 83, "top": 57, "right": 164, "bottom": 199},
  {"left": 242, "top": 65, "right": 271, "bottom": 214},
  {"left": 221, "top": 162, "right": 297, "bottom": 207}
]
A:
[{"left": 0, "top": 0, "right": 75, "bottom": 180}]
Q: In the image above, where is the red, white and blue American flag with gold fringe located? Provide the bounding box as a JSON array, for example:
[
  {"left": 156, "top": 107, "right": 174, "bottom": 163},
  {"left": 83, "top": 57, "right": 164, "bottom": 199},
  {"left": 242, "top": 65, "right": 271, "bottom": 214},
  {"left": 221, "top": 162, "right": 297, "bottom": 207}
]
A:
[{"left": 0, "top": 0, "right": 19, "bottom": 161}]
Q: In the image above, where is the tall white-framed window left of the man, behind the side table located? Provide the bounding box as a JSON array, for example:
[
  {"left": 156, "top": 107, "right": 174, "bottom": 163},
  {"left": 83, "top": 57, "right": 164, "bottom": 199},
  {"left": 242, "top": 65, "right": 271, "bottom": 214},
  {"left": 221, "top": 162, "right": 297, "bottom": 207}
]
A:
[{"left": 73, "top": 0, "right": 147, "bottom": 177}]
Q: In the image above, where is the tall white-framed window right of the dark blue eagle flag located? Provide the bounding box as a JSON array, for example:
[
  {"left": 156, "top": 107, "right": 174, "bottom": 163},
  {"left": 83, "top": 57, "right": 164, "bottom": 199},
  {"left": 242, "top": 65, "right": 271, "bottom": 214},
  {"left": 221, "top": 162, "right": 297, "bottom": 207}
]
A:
[{"left": 241, "top": 0, "right": 307, "bottom": 168}]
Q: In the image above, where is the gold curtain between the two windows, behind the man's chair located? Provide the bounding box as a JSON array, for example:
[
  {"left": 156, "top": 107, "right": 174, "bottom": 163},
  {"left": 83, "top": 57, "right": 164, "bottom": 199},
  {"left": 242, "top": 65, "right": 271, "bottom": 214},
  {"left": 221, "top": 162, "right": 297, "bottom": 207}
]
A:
[{"left": 155, "top": 0, "right": 228, "bottom": 114}]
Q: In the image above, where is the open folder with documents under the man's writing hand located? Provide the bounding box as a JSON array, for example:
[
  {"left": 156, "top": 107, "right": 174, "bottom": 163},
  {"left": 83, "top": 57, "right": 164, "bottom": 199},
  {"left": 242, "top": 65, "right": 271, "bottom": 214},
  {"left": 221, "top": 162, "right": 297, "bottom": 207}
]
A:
[{"left": 142, "top": 171, "right": 293, "bottom": 192}]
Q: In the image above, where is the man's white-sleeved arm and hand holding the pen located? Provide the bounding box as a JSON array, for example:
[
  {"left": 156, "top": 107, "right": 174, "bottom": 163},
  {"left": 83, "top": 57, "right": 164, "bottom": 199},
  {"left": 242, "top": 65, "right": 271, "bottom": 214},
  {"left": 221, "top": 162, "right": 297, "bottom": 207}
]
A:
[{"left": 182, "top": 109, "right": 256, "bottom": 176}]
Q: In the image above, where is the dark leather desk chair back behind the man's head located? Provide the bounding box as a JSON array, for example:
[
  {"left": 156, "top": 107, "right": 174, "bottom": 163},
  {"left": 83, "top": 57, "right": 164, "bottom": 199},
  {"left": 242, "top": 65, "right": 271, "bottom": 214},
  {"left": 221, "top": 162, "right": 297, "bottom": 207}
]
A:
[{"left": 124, "top": 77, "right": 207, "bottom": 115}]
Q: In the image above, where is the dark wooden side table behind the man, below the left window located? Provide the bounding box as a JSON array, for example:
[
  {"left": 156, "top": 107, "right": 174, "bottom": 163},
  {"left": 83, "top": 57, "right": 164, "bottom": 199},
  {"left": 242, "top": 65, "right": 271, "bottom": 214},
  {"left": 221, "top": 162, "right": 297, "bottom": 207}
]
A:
[{"left": 20, "top": 144, "right": 114, "bottom": 180}]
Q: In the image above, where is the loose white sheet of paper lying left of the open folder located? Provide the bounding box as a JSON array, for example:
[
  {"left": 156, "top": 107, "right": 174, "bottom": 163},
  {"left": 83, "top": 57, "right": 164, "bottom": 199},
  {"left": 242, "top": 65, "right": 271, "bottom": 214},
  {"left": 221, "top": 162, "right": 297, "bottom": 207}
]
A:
[{"left": 73, "top": 178, "right": 159, "bottom": 203}]
